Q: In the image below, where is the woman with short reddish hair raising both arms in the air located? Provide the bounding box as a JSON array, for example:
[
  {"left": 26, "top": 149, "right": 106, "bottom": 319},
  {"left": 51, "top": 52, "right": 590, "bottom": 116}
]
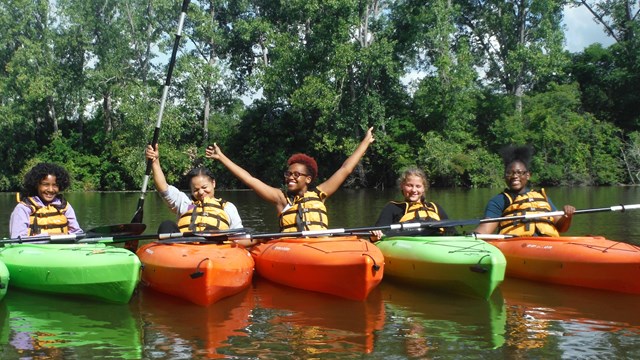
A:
[{"left": 205, "top": 128, "right": 374, "bottom": 232}]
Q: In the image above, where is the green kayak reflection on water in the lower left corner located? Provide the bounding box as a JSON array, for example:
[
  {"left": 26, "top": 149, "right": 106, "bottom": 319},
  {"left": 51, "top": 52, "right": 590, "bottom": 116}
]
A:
[{"left": 0, "top": 289, "right": 142, "bottom": 359}]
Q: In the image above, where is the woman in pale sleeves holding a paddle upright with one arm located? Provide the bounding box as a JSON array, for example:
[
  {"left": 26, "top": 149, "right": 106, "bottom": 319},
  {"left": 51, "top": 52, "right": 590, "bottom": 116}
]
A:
[{"left": 145, "top": 145, "right": 242, "bottom": 234}]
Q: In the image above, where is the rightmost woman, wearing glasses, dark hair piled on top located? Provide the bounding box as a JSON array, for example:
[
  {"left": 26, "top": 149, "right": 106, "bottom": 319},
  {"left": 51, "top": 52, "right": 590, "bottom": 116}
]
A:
[{"left": 475, "top": 146, "right": 576, "bottom": 237}]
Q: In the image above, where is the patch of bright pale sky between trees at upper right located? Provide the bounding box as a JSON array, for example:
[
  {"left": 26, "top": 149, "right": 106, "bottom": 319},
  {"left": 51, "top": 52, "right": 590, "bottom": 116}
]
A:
[{"left": 563, "top": 5, "right": 614, "bottom": 52}]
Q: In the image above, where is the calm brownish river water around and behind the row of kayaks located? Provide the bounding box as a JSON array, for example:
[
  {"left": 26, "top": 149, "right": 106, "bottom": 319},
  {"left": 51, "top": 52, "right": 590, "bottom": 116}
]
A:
[{"left": 0, "top": 187, "right": 640, "bottom": 359}]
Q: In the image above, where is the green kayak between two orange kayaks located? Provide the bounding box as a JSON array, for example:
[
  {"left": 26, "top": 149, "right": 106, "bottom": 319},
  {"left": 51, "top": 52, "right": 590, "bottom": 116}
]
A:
[{"left": 376, "top": 236, "right": 507, "bottom": 299}]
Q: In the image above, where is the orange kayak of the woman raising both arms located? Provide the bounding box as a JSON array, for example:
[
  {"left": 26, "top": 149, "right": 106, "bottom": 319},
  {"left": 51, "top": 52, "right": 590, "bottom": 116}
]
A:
[{"left": 251, "top": 236, "right": 384, "bottom": 301}]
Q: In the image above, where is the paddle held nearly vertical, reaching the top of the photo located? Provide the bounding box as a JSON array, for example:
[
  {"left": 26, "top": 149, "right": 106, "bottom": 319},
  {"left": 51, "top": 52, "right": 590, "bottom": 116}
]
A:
[{"left": 125, "top": 0, "right": 190, "bottom": 252}]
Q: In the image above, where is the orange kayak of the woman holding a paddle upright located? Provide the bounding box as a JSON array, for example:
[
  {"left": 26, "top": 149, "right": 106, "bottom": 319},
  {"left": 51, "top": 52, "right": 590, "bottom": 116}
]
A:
[{"left": 136, "top": 242, "right": 254, "bottom": 306}]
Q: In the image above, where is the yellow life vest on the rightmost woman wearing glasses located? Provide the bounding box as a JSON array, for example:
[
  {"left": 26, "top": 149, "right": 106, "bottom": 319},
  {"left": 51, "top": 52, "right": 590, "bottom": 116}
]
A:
[{"left": 498, "top": 189, "right": 560, "bottom": 237}]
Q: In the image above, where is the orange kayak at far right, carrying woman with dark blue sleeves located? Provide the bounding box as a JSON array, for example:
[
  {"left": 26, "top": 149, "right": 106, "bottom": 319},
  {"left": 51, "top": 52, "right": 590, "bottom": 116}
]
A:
[{"left": 487, "top": 236, "right": 640, "bottom": 294}]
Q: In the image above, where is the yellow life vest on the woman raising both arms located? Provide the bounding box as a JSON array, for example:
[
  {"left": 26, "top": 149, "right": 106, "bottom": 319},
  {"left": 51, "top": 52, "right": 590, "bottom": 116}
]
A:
[{"left": 280, "top": 189, "right": 329, "bottom": 232}]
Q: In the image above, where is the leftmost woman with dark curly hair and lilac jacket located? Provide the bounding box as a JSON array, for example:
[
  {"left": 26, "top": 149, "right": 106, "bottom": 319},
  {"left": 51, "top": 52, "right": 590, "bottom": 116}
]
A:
[{"left": 9, "top": 163, "right": 82, "bottom": 238}]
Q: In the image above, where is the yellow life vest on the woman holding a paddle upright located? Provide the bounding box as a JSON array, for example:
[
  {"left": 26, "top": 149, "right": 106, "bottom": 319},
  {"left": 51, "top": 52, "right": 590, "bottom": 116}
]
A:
[{"left": 178, "top": 197, "right": 230, "bottom": 232}]
